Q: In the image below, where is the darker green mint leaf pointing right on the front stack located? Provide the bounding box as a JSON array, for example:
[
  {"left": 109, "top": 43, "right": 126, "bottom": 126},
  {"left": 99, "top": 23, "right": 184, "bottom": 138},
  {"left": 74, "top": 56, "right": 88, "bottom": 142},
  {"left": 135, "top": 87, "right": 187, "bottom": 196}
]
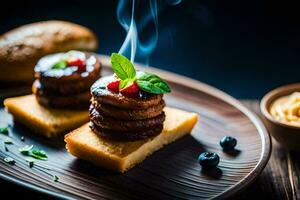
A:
[{"left": 136, "top": 72, "right": 171, "bottom": 94}]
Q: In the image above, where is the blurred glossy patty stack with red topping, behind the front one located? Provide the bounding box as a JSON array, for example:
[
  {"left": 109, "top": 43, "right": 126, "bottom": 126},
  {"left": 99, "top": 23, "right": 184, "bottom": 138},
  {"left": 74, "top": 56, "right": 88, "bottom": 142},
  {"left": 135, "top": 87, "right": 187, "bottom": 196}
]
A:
[{"left": 32, "top": 51, "right": 101, "bottom": 110}]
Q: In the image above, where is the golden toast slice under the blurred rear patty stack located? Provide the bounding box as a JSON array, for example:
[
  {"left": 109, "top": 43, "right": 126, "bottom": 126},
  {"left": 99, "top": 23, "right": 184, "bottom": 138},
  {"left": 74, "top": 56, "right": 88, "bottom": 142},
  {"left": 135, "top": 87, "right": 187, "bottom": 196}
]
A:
[{"left": 4, "top": 95, "right": 89, "bottom": 137}]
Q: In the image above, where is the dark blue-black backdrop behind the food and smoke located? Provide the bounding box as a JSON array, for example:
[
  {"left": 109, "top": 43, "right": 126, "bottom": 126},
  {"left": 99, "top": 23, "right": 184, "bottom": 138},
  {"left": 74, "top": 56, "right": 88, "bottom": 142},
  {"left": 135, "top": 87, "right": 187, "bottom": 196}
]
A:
[{"left": 0, "top": 0, "right": 300, "bottom": 98}]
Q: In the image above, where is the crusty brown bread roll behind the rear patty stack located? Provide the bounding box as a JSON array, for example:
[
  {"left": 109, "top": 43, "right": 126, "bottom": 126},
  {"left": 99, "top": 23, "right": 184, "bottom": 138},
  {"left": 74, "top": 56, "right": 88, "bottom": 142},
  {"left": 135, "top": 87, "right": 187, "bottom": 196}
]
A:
[{"left": 0, "top": 21, "right": 98, "bottom": 82}]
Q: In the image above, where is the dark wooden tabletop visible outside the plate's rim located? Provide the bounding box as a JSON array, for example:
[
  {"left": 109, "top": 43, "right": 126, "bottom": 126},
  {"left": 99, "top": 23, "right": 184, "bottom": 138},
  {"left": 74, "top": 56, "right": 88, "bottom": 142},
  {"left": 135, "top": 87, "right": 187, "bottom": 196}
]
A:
[{"left": 0, "top": 100, "right": 300, "bottom": 200}]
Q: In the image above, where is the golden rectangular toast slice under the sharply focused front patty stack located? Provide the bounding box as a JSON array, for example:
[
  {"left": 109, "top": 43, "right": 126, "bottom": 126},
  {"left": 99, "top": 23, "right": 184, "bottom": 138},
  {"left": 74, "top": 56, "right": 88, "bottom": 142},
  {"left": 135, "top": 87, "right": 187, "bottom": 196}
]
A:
[{"left": 65, "top": 107, "right": 198, "bottom": 172}]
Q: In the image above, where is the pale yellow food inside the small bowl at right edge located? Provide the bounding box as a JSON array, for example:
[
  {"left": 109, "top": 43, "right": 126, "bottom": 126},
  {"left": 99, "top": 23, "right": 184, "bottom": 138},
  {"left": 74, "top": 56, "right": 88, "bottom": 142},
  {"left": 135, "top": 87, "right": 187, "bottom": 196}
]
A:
[{"left": 270, "top": 92, "right": 300, "bottom": 127}]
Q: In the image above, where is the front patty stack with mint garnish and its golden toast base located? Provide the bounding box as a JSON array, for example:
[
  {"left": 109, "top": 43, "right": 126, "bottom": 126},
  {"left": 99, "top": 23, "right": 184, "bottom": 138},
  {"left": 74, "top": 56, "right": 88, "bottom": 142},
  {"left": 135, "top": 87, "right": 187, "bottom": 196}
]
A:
[{"left": 65, "top": 54, "right": 198, "bottom": 172}]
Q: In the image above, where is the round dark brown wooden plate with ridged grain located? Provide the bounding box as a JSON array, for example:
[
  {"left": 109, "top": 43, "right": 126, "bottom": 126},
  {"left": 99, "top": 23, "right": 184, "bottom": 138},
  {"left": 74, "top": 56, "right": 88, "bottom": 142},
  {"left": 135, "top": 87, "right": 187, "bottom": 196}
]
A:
[{"left": 0, "top": 56, "right": 271, "bottom": 199}]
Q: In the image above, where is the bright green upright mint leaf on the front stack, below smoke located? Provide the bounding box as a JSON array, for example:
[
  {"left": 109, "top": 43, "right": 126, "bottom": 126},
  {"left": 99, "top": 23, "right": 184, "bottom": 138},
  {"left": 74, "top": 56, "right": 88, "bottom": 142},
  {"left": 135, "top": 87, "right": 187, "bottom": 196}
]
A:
[{"left": 110, "top": 53, "right": 136, "bottom": 80}]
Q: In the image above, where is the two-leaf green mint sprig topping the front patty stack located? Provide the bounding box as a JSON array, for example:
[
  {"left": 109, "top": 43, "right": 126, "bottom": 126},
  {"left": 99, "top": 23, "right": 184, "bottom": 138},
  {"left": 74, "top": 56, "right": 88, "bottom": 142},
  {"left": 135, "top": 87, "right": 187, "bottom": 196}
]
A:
[{"left": 111, "top": 53, "right": 171, "bottom": 94}]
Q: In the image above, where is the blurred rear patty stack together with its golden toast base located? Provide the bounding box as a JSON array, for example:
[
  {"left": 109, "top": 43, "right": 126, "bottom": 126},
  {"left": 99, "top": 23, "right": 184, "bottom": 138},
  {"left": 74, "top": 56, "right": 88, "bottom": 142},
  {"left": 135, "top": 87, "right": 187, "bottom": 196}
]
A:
[{"left": 4, "top": 51, "right": 101, "bottom": 137}]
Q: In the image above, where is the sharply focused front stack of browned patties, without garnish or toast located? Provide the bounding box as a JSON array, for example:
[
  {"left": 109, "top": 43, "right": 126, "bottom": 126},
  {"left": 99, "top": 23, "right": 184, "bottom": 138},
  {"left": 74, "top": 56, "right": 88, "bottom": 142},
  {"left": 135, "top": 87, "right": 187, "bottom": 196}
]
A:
[{"left": 90, "top": 76, "right": 165, "bottom": 141}]
